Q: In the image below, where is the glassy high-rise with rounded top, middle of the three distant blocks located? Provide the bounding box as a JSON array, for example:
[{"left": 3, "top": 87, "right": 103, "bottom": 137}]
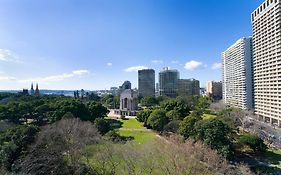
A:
[{"left": 159, "top": 68, "right": 180, "bottom": 98}]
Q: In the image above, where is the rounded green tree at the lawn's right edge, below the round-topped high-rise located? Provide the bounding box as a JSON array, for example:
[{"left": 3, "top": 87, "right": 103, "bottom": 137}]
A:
[{"left": 147, "top": 109, "right": 169, "bottom": 131}]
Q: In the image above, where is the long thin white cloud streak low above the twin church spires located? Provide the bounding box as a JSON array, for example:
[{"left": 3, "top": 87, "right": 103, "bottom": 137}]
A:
[{"left": 19, "top": 70, "right": 90, "bottom": 83}]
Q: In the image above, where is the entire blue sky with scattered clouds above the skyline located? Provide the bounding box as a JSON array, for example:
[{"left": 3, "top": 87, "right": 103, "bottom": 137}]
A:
[{"left": 0, "top": 0, "right": 263, "bottom": 90}]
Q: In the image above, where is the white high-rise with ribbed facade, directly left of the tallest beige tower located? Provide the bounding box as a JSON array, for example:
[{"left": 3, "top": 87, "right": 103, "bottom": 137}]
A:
[{"left": 222, "top": 38, "right": 253, "bottom": 109}]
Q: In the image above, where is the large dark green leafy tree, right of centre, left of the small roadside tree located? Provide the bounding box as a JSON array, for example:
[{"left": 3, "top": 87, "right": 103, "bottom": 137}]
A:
[{"left": 195, "top": 118, "right": 233, "bottom": 158}]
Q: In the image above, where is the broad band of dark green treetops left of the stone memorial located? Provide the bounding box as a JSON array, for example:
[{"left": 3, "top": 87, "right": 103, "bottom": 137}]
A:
[{"left": 0, "top": 95, "right": 108, "bottom": 125}]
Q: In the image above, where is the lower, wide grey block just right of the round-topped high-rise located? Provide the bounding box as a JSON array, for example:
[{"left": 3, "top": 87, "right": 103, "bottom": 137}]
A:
[{"left": 178, "top": 79, "right": 200, "bottom": 96}]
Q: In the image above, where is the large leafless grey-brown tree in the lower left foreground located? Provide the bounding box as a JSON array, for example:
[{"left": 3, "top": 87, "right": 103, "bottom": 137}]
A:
[{"left": 16, "top": 118, "right": 100, "bottom": 175}]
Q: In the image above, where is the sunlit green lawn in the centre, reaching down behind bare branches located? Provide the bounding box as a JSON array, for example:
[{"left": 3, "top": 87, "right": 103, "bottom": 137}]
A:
[{"left": 84, "top": 118, "right": 157, "bottom": 174}]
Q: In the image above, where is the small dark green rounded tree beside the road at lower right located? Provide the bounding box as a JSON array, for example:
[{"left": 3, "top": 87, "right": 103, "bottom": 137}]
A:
[{"left": 239, "top": 134, "right": 267, "bottom": 152}]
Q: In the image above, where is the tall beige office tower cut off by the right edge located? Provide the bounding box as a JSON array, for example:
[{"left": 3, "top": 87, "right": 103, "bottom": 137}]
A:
[{"left": 252, "top": 0, "right": 281, "bottom": 126}]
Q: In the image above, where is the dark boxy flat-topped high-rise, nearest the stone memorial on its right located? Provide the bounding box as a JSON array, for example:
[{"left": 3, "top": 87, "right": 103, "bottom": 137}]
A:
[{"left": 138, "top": 69, "right": 155, "bottom": 97}]
